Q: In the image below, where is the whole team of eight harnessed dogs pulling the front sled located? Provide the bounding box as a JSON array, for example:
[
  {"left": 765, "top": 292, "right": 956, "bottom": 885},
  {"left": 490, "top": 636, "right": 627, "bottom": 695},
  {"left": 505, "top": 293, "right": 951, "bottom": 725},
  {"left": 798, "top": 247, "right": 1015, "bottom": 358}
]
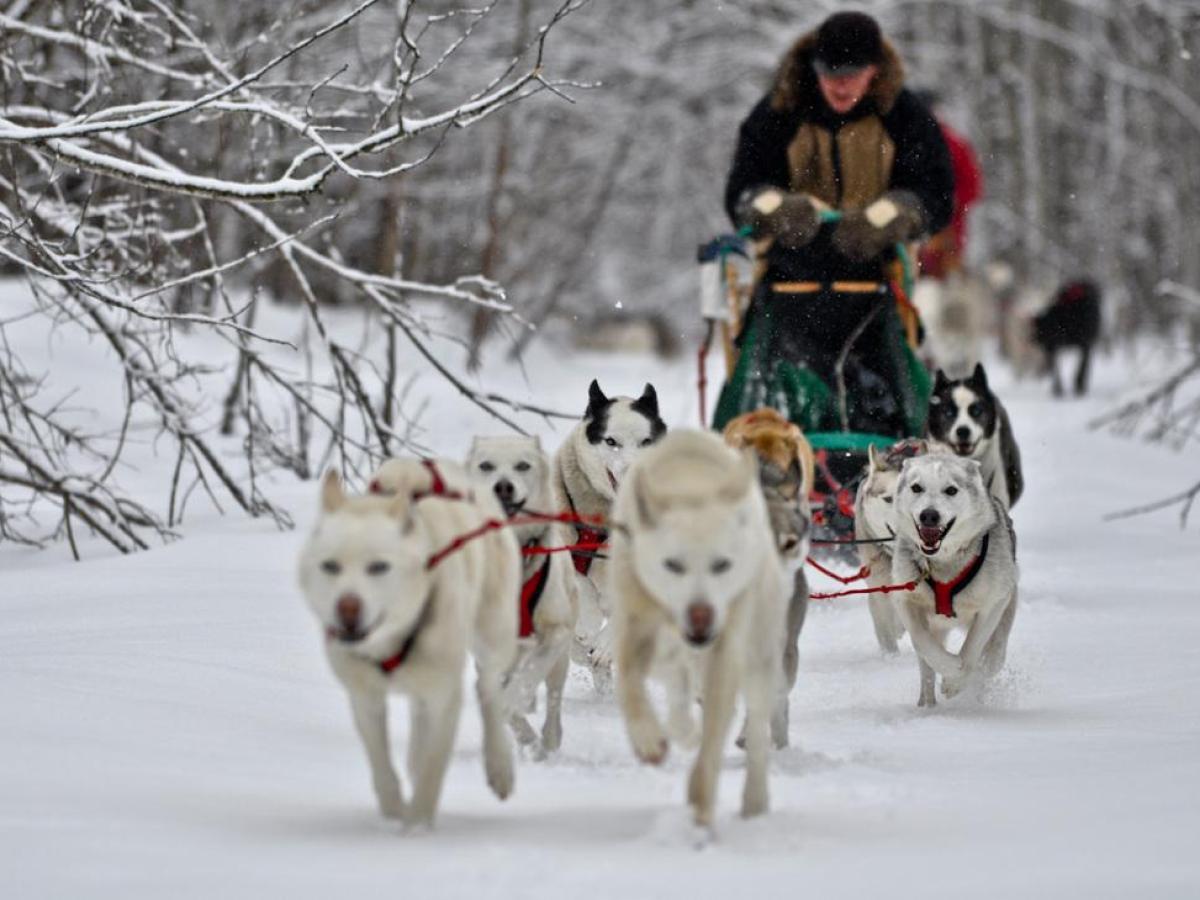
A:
[{"left": 299, "top": 367, "right": 1021, "bottom": 828}]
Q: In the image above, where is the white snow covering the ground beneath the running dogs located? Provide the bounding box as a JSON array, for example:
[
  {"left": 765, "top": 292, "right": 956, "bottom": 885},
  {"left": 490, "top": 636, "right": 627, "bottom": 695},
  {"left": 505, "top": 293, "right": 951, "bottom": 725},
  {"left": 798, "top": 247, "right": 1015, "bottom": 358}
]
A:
[{"left": 0, "top": 292, "right": 1200, "bottom": 899}]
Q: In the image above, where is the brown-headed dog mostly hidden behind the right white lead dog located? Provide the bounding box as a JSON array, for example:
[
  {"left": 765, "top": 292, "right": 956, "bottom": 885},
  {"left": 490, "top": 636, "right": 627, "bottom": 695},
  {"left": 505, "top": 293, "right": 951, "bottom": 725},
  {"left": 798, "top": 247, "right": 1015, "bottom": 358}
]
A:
[{"left": 722, "top": 407, "right": 814, "bottom": 748}]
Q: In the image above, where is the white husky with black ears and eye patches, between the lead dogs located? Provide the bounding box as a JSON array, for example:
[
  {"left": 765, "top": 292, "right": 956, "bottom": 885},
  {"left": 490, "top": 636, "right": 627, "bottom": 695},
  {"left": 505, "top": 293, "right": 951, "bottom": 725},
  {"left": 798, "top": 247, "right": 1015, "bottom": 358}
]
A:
[{"left": 554, "top": 380, "right": 667, "bottom": 689}]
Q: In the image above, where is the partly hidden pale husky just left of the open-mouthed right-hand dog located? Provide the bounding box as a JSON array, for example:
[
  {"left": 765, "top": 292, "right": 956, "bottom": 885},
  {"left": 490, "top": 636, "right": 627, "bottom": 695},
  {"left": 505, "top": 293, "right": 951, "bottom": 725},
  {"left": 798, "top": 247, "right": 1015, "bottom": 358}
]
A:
[{"left": 854, "top": 439, "right": 929, "bottom": 653}]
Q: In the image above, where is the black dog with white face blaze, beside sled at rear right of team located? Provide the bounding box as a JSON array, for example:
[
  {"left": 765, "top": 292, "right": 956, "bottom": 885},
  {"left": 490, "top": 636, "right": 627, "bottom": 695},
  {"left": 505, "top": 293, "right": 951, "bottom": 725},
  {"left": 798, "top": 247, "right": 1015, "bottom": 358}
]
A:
[{"left": 929, "top": 362, "right": 1025, "bottom": 509}]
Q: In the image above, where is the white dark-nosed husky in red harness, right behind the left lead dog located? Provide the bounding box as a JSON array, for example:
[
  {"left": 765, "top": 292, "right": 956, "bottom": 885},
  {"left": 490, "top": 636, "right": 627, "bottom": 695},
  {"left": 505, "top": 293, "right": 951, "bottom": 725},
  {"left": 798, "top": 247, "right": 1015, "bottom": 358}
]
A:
[{"left": 467, "top": 436, "right": 578, "bottom": 757}]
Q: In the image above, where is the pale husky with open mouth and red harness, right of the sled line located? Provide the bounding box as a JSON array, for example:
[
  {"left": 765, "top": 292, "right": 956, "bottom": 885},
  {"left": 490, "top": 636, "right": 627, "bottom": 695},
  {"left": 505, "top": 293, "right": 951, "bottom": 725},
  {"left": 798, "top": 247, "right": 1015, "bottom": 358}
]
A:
[{"left": 892, "top": 454, "right": 1016, "bottom": 707}]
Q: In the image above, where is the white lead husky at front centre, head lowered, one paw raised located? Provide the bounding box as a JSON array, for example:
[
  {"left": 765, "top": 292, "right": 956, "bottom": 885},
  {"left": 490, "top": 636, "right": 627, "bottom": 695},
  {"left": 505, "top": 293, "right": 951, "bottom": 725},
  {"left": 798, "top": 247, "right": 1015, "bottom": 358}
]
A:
[{"left": 610, "top": 431, "right": 788, "bottom": 827}]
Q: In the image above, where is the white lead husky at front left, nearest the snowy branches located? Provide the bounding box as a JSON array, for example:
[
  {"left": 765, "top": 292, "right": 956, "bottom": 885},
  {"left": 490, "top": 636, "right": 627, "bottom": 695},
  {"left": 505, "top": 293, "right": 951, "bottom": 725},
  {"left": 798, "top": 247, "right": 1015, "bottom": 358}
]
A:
[{"left": 300, "top": 460, "right": 520, "bottom": 826}]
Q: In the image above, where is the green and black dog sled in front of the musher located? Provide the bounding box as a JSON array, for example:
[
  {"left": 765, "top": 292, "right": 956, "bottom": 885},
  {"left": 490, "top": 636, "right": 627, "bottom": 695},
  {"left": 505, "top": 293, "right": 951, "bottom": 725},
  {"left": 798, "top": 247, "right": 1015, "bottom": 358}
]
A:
[{"left": 697, "top": 226, "right": 932, "bottom": 558}]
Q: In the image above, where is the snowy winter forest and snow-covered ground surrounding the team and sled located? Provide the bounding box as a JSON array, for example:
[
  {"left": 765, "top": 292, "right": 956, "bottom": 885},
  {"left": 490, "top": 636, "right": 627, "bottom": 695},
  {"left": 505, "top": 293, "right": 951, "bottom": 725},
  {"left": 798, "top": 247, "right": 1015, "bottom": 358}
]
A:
[{"left": 0, "top": 0, "right": 1200, "bottom": 898}]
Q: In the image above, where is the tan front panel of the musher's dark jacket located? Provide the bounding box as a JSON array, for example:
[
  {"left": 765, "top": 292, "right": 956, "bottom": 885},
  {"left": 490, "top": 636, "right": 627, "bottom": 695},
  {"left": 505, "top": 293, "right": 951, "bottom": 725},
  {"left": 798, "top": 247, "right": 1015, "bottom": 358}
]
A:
[{"left": 787, "top": 115, "right": 896, "bottom": 210}]
